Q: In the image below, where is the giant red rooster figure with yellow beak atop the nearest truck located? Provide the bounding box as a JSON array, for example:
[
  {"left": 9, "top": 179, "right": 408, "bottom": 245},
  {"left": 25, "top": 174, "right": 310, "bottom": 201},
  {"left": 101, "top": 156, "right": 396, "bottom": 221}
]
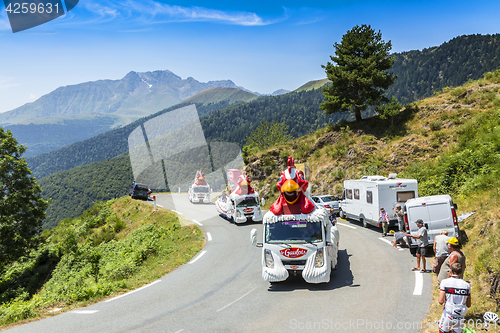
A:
[{"left": 270, "top": 157, "right": 316, "bottom": 215}]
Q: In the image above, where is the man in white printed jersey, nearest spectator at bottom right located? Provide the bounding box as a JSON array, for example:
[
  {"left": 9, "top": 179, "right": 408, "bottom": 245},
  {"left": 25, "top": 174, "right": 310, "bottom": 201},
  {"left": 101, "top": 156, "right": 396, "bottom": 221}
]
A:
[{"left": 438, "top": 262, "right": 472, "bottom": 333}]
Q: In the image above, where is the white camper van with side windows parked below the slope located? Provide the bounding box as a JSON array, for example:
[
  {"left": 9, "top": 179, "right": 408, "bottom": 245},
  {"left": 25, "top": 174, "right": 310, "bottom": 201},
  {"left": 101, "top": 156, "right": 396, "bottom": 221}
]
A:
[{"left": 339, "top": 174, "right": 418, "bottom": 227}]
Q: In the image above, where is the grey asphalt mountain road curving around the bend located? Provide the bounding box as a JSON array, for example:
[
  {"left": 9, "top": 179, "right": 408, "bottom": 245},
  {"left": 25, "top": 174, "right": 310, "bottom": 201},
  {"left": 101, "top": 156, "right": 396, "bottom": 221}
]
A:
[{"left": 7, "top": 194, "right": 437, "bottom": 333}]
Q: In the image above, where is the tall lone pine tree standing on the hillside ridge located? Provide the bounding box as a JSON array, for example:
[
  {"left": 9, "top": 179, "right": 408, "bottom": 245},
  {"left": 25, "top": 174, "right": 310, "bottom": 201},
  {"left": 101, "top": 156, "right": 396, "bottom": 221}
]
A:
[{"left": 320, "top": 25, "right": 396, "bottom": 121}]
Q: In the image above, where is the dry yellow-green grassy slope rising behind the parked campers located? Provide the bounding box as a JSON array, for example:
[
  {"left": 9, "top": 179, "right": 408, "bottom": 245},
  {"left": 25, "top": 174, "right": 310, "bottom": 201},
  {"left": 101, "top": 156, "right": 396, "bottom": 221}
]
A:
[{"left": 246, "top": 70, "right": 500, "bottom": 332}]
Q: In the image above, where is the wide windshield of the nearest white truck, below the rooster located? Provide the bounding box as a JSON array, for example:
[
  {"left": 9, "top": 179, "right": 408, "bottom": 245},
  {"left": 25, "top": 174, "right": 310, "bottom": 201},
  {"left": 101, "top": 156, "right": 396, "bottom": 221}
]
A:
[{"left": 266, "top": 221, "right": 322, "bottom": 244}]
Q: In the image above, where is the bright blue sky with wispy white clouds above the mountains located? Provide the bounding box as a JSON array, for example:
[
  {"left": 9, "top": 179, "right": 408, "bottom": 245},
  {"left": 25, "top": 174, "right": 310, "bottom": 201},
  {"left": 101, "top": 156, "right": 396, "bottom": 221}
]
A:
[{"left": 0, "top": 0, "right": 500, "bottom": 112}]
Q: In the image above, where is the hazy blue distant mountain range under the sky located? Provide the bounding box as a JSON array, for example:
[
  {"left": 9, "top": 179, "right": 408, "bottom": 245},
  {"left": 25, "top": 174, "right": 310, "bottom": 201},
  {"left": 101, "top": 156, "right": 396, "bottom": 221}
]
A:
[{"left": 0, "top": 70, "right": 258, "bottom": 157}]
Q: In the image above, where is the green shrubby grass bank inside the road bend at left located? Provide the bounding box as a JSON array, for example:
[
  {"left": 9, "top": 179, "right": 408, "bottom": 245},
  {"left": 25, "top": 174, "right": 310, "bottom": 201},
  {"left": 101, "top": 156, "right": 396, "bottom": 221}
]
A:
[{"left": 0, "top": 197, "right": 204, "bottom": 327}]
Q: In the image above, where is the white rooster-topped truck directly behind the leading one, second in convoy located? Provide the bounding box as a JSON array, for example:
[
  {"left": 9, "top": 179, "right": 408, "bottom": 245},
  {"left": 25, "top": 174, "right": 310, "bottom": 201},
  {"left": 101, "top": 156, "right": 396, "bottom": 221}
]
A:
[{"left": 215, "top": 172, "right": 262, "bottom": 224}]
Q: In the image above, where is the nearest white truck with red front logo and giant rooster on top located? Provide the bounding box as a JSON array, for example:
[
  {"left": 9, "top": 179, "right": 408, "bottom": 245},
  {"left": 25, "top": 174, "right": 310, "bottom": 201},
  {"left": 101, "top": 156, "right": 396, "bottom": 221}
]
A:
[{"left": 250, "top": 157, "right": 339, "bottom": 283}]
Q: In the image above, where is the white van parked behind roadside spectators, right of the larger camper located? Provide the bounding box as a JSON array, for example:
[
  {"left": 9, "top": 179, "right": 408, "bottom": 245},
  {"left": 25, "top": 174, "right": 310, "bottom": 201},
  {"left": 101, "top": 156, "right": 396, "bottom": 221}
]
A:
[{"left": 404, "top": 194, "right": 459, "bottom": 254}]
